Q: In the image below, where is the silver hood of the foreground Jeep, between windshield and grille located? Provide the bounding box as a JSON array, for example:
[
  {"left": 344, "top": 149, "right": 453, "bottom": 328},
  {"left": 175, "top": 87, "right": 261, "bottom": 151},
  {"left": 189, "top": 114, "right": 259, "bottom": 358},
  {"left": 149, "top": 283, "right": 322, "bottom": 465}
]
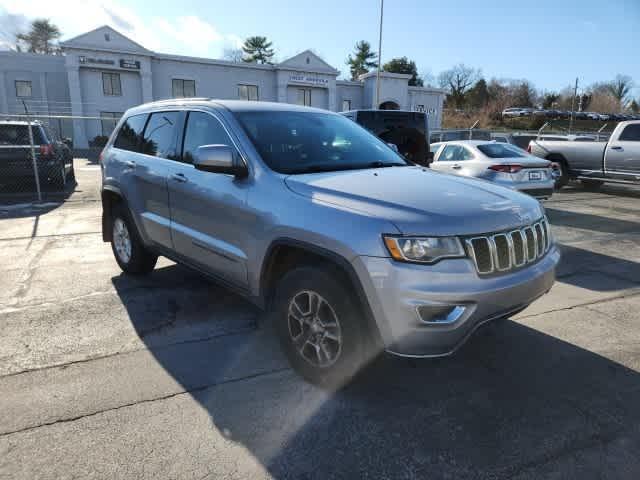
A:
[{"left": 285, "top": 167, "right": 544, "bottom": 235}]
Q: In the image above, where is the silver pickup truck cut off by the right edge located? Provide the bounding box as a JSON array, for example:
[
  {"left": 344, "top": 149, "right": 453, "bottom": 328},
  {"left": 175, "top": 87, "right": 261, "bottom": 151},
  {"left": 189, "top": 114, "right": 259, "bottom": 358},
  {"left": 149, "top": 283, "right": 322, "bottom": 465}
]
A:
[{"left": 527, "top": 120, "right": 640, "bottom": 187}]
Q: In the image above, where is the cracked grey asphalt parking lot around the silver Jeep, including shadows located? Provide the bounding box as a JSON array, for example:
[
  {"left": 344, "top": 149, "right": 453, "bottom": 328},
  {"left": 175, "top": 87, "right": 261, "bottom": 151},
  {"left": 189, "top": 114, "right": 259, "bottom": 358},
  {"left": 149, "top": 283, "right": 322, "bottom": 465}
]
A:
[{"left": 0, "top": 159, "right": 640, "bottom": 479}]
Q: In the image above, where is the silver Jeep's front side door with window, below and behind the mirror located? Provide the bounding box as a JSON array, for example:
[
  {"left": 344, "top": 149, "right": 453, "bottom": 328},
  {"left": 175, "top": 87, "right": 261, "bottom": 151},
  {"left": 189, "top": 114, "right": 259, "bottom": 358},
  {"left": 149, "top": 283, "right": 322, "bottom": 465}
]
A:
[{"left": 168, "top": 111, "right": 250, "bottom": 288}]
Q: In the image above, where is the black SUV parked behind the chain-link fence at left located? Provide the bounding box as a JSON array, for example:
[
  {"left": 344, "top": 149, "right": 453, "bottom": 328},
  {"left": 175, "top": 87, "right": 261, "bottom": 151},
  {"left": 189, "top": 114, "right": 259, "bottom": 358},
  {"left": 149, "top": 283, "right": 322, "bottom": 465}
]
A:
[{"left": 0, "top": 120, "right": 75, "bottom": 189}]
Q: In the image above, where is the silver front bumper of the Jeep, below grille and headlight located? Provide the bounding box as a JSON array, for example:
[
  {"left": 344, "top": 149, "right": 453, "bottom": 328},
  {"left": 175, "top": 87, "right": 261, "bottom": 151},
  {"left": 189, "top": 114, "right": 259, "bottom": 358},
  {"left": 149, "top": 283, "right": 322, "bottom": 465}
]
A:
[{"left": 353, "top": 246, "right": 560, "bottom": 357}]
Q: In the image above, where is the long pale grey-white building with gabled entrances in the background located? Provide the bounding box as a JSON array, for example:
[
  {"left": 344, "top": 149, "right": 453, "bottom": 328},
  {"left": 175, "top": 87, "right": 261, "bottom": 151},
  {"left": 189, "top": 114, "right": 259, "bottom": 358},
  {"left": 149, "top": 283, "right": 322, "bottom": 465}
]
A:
[{"left": 0, "top": 26, "right": 444, "bottom": 148}]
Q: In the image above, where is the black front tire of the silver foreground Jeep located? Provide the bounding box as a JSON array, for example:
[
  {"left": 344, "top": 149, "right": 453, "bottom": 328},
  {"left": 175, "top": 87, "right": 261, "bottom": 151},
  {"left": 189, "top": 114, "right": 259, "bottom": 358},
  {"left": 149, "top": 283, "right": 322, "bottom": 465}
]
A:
[{"left": 273, "top": 266, "right": 377, "bottom": 389}]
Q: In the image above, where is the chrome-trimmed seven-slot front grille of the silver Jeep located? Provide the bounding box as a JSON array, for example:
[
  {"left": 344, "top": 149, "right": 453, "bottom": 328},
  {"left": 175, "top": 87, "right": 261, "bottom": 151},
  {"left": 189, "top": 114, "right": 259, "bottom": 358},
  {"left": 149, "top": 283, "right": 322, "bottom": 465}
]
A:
[{"left": 465, "top": 219, "right": 551, "bottom": 275}]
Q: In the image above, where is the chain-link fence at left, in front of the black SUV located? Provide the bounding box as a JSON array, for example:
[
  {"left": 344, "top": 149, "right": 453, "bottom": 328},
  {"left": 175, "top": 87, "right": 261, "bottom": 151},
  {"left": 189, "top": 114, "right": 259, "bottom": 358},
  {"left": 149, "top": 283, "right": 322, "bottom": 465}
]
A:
[{"left": 0, "top": 113, "right": 111, "bottom": 201}]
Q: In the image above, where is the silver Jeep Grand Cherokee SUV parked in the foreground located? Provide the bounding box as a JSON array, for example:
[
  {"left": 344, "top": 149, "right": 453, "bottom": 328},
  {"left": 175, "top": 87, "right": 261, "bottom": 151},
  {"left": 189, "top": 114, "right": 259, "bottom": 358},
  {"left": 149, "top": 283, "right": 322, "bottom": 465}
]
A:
[{"left": 101, "top": 99, "right": 559, "bottom": 386}]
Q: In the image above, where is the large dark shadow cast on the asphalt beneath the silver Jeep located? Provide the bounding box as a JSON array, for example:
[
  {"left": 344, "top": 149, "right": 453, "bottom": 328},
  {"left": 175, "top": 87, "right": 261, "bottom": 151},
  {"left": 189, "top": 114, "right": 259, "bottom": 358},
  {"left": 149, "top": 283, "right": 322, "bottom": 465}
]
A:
[{"left": 113, "top": 266, "right": 640, "bottom": 479}]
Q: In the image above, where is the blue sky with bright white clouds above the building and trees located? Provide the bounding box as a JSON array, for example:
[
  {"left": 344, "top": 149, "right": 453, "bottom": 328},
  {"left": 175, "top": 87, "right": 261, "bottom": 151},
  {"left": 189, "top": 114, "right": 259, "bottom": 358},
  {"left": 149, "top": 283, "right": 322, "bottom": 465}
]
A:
[{"left": 0, "top": 0, "right": 640, "bottom": 97}]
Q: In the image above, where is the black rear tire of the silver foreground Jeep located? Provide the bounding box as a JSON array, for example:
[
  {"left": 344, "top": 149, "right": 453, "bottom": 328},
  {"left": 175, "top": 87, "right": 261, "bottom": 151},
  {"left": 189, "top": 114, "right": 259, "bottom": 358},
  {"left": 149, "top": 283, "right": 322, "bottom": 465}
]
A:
[{"left": 111, "top": 205, "right": 158, "bottom": 275}]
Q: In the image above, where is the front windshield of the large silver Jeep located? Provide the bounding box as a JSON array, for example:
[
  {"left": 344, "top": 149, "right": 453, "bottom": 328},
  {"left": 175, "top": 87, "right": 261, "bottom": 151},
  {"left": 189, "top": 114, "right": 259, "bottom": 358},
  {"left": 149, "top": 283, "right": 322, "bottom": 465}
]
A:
[{"left": 236, "top": 112, "right": 408, "bottom": 174}]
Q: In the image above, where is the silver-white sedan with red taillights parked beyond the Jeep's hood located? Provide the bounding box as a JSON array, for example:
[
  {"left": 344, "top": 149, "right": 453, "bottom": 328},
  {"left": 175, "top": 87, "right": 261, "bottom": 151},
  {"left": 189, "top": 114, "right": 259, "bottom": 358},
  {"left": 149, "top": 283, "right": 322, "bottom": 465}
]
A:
[{"left": 431, "top": 140, "right": 554, "bottom": 199}]
